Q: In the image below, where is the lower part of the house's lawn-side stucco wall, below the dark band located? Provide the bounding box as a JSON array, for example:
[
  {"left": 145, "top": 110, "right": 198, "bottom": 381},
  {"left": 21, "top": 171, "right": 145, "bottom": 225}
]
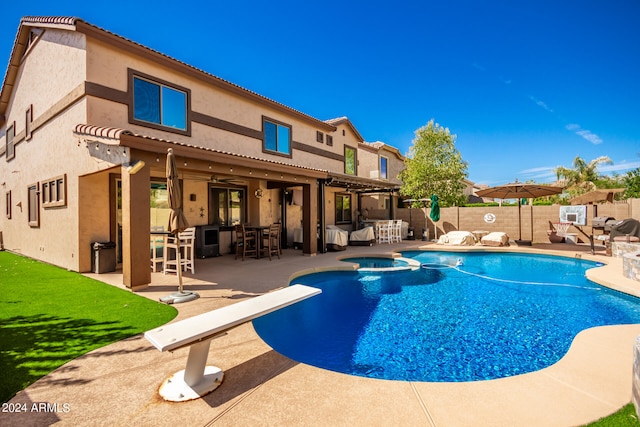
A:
[{"left": 0, "top": 102, "right": 87, "bottom": 270}]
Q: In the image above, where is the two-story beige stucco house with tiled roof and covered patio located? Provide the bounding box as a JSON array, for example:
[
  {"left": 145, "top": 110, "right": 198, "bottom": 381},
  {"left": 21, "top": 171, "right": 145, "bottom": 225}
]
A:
[{"left": 0, "top": 17, "right": 404, "bottom": 288}]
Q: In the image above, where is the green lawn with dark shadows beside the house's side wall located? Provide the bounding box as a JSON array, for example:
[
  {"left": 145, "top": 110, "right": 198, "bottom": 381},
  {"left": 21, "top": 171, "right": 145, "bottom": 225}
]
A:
[{"left": 0, "top": 252, "right": 178, "bottom": 402}]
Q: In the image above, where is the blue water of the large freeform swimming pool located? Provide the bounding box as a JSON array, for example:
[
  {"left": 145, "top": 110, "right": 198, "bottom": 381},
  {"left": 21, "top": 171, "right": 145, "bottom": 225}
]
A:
[{"left": 253, "top": 252, "right": 640, "bottom": 382}]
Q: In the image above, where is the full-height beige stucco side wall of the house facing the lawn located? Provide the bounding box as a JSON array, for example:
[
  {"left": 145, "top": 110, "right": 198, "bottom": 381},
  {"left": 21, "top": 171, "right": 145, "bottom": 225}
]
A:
[{"left": 0, "top": 29, "right": 88, "bottom": 270}]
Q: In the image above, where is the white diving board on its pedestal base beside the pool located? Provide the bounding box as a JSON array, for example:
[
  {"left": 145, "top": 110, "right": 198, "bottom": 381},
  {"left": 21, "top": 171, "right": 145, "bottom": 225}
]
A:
[{"left": 144, "top": 285, "right": 322, "bottom": 402}]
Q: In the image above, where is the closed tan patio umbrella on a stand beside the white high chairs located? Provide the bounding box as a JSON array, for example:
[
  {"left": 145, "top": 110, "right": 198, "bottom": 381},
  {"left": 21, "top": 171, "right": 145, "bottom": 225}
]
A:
[{"left": 160, "top": 148, "right": 199, "bottom": 304}]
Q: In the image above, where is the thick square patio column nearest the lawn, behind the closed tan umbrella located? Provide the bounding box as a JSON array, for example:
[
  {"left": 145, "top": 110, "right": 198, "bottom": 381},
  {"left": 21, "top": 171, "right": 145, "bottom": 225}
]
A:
[{"left": 122, "top": 161, "right": 151, "bottom": 290}]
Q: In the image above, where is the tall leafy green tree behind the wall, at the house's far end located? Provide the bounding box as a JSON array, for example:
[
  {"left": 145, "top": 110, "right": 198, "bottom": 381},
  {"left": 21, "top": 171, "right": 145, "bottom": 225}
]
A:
[{"left": 400, "top": 119, "right": 468, "bottom": 206}]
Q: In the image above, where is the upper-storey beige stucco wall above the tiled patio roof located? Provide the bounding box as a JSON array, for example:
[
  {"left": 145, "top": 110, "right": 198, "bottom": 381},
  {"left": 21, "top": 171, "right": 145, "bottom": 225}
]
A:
[{"left": 87, "top": 39, "right": 357, "bottom": 176}]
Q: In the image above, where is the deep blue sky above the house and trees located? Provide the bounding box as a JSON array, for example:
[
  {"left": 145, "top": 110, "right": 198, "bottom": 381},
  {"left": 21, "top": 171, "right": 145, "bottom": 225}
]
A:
[{"left": 0, "top": 0, "right": 640, "bottom": 185}]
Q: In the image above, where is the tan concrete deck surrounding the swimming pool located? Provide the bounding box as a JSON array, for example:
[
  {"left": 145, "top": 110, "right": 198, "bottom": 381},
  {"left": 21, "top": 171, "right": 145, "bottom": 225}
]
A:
[{"left": 0, "top": 241, "right": 640, "bottom": 426}]
